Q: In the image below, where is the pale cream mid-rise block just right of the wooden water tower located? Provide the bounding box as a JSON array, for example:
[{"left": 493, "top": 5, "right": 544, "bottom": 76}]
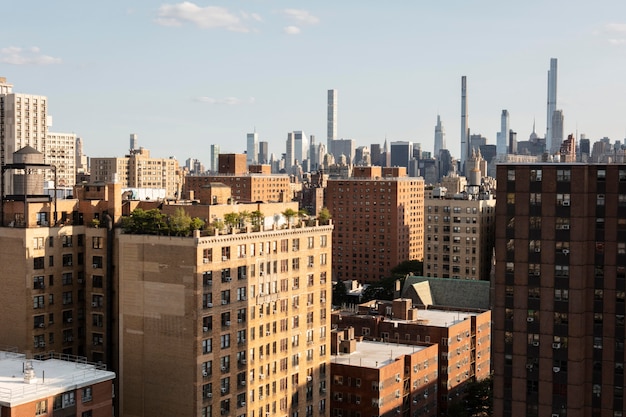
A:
[{"left": 44, "top": 132, "right": 76, "bottom": 188}]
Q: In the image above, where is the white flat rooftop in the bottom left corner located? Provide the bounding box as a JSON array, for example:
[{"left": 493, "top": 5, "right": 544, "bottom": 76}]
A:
[{"left": 0, "top": 351, "right": 115, "bottom": 407}]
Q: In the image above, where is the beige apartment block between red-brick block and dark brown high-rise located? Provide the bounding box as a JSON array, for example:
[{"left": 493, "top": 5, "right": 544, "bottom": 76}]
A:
[{"left": 424, "top": 188, "right": 496, "bottom": 280}]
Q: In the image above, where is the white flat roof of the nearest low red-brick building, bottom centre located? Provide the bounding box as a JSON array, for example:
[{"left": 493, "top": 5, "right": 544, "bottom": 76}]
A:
[{"left": 331, "top": 340, "right": 428, "bottom": 369}]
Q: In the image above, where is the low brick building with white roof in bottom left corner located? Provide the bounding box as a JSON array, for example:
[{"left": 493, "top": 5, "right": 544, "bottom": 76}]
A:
[{"left": 0, "top": 351, "right": 115, "bottom": 417}]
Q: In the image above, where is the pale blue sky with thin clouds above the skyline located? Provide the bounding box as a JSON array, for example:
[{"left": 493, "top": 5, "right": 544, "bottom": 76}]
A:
[{"left": 0, "top": 0, "right": 626, "bottom": 165}]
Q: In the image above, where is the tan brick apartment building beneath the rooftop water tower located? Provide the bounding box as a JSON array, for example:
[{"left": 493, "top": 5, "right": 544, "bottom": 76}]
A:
[{"left": 0, "top": 185, "right": 121, "bottom": 366}]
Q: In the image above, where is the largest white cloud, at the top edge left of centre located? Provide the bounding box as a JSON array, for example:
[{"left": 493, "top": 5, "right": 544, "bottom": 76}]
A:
[{"left": 155, "top": 1, "right": 250, "bottom": 32}]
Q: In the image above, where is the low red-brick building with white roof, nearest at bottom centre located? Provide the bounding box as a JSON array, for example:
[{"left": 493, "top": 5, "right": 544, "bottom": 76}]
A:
[{"left": 330, "top": 328, "right": 439, "bottom": 417}]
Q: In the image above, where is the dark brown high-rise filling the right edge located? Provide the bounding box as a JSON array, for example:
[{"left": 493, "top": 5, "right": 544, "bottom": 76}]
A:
[{"left": 492, "top": 163, "right": 626, "bottom": 417}]
